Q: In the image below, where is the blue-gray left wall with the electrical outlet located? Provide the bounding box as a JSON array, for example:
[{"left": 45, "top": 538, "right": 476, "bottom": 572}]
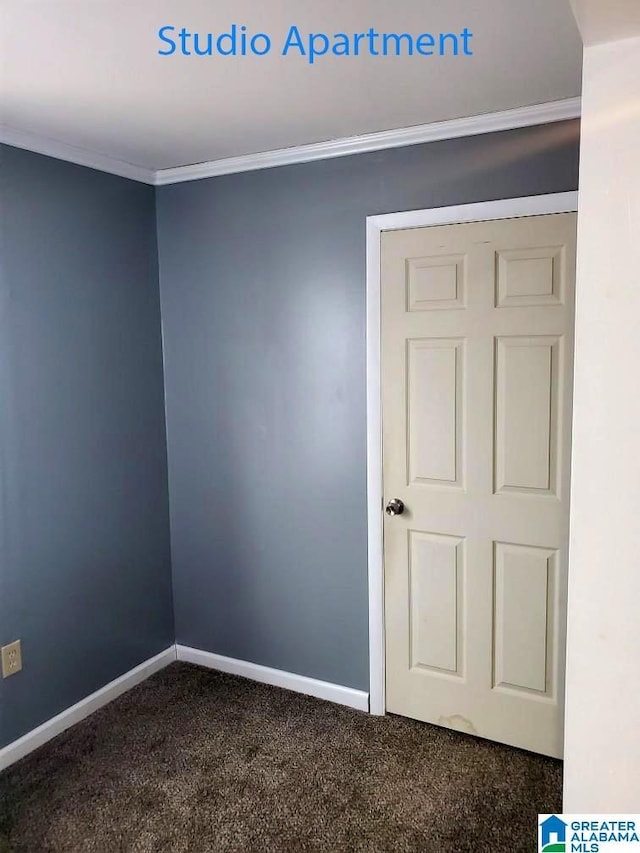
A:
[{"left": 0, "top": 147, "right": 174, "bottom": 746}]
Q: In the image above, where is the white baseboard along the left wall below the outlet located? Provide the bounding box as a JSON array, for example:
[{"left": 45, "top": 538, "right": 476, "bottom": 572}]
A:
[{"left": 0, "top": 646, "right": 176, "bottom": 771}]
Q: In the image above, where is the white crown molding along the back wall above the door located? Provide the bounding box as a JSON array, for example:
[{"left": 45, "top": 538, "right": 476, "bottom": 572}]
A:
[{"left": 155, "top": 98, "right": 581, "bottom": 186}]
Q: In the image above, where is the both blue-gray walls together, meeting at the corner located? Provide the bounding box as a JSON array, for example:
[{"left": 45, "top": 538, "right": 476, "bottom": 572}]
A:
[{"left": 0, "top": 122, "right": 578, "bottom": 746}]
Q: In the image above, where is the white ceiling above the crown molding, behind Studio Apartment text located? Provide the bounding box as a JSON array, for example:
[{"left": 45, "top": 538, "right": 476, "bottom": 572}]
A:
[{"left": 0, "top": 0, "right": 584, "bottom": 170}]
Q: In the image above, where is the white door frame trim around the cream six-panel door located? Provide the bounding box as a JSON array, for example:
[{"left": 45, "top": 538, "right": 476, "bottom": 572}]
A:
[{"left": 367, "top": 192, "right": 578, "bottom": 714}]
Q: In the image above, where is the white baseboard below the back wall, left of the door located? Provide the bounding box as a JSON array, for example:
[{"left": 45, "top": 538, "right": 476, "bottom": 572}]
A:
[{"left": 176, "top": 645, "right": 369, "bottom": 711}]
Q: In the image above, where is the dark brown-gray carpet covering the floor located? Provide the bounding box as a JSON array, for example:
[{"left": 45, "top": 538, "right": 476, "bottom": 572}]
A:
[{"left": 0, "top": 663, "right": 562, "bottom": 853}]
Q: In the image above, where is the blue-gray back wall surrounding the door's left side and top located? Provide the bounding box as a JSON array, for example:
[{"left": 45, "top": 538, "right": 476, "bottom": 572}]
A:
[{"left": 157, "top": 122, "right": 578, "bottom": 689}]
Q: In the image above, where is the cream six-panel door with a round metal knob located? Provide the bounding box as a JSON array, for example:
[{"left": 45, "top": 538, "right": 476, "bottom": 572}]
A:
[{"left": 381, "top": 213, "right": 576, "bottom": 756}]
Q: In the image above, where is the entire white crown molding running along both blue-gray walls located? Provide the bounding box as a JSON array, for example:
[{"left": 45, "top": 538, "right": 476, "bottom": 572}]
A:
[{"left": 0, "top": 98, "right": 581, "bottom": 186}]
